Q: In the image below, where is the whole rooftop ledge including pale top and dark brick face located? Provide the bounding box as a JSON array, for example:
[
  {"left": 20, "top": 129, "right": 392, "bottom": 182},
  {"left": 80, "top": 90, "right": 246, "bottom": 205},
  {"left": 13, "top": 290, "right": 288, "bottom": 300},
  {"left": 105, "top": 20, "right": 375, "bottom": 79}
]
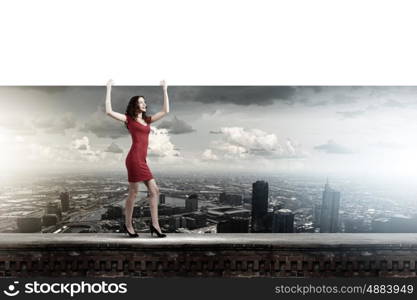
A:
[{"left": 0, "top": 233, "right": 417, "bottom": 277}]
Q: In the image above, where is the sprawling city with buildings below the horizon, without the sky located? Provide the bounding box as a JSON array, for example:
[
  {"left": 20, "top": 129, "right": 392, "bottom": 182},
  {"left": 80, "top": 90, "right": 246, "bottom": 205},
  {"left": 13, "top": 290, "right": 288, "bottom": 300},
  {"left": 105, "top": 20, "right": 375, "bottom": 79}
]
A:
[{"left": 0, "top": 172, "right": 417, "bottom": 234}]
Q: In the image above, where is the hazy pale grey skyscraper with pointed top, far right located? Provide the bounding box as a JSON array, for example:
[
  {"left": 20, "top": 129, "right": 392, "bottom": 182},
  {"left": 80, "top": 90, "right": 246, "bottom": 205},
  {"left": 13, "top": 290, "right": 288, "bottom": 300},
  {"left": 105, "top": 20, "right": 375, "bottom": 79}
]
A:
[{"left": 320, "top": 180, "right": 340, "bottom": 232}]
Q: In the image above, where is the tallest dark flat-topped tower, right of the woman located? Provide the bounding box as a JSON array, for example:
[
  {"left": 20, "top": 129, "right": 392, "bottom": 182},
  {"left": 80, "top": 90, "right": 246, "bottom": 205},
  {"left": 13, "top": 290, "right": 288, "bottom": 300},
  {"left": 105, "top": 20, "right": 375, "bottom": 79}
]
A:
[{"left": 251, "top": 180, "right": 268, "bottom": 232}]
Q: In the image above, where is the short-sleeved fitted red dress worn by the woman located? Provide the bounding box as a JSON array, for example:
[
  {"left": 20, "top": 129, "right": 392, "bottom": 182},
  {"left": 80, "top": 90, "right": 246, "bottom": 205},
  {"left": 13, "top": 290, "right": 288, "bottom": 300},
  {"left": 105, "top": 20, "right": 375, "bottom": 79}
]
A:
[{"left": 125, "top": 114, "right": 153, "bottom": 182}]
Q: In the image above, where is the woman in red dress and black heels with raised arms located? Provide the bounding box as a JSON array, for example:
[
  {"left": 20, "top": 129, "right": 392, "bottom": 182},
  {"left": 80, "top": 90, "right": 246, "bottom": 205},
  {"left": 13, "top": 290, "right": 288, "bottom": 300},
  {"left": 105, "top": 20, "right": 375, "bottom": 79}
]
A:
[{"left": 106, "top": 80, "right": 169, "bottom": 237}]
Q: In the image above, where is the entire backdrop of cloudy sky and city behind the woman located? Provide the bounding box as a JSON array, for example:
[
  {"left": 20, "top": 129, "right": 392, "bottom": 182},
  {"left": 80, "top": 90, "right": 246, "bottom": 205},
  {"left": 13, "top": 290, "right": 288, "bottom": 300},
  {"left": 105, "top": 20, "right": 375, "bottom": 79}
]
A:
[{"left": 0, "top": 86, "right": 417, "bottom": 234}]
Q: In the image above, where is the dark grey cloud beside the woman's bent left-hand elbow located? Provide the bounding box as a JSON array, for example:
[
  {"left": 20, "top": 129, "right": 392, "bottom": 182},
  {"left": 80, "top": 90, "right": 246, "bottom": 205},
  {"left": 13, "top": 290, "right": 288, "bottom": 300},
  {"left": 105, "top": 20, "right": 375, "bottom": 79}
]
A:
[{"left": 79, "top": 107, "right": 129, "bottom": 139}]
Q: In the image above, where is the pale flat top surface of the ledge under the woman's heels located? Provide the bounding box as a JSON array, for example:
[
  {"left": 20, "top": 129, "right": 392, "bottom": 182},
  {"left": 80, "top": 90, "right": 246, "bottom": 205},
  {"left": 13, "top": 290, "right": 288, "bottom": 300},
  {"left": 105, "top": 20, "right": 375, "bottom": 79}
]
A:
[{"left": 0, "top": 233, "right": 417, "bottom": 250}]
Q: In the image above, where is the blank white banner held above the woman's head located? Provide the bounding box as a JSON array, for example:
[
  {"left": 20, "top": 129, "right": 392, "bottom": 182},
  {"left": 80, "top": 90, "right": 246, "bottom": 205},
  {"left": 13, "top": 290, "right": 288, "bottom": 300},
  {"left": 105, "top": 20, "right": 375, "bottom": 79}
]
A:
[{"left": 0, "top": 0, "right": 417, "bottom": 85}]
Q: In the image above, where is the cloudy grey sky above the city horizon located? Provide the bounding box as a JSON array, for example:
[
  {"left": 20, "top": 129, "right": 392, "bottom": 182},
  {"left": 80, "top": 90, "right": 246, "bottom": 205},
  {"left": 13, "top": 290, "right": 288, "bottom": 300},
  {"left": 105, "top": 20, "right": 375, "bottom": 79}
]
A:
[{"left": 0, "top": 86, "right": 417, "bottom": 178}]
